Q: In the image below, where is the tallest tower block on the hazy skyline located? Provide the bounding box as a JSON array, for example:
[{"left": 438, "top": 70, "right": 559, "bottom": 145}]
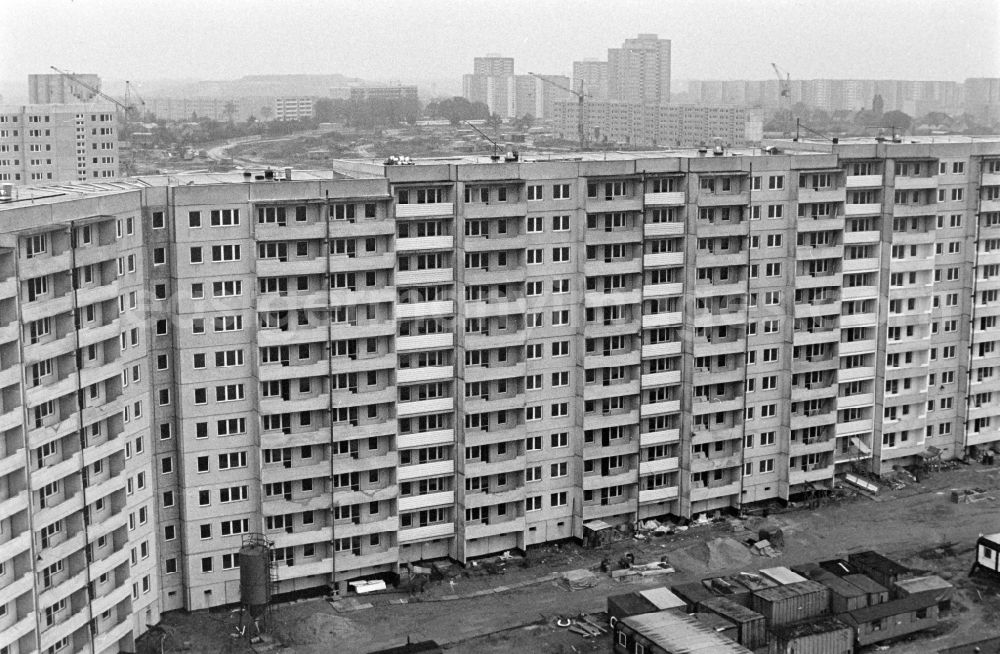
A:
[{"left": 608, "top": 34, "right": 670, "bottom": 104}]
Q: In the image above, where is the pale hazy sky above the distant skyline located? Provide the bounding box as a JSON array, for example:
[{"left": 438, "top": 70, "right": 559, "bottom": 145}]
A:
[{"left": 0, "top": 0, "right": 1000, "bottom": 83}]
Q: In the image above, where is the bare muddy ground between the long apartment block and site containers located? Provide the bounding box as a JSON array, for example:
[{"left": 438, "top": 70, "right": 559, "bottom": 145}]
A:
[{"left": 146, "top": 464, "right": 1000, "bottom": 654}]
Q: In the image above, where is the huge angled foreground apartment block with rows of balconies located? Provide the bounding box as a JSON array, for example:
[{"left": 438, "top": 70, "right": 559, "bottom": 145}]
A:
[{"left": 0, "top": 138, "right": 1000, "bottom": 654}]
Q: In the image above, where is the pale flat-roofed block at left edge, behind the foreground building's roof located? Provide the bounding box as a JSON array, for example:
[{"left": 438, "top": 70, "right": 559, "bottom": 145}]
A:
[{"left": 0, "top": 104, "right": 119, "bottom": 185}]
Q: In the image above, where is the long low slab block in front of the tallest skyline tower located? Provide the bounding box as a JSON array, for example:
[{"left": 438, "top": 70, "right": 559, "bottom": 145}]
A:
[{"left": 553, "top": 100, "right": 760, "bottom": 147}]
